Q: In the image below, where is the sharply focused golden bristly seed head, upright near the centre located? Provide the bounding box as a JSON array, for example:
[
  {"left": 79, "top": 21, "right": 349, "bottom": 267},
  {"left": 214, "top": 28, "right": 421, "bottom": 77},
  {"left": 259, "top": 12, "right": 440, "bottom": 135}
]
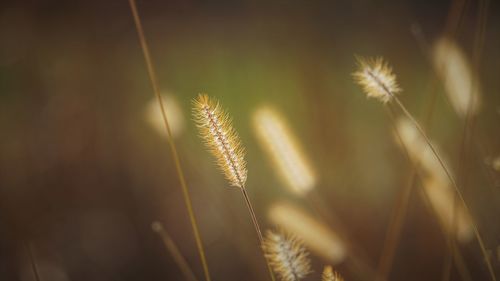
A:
[{"left": 193, "top": 94, "right": 247, "bottom": 188}]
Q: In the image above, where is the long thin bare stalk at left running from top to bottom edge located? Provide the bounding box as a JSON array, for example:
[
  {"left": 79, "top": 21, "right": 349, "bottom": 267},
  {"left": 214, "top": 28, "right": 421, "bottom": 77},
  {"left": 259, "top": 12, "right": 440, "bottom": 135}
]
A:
[{"left": 129, "top": 0, "right": 211, "bottom": 281}]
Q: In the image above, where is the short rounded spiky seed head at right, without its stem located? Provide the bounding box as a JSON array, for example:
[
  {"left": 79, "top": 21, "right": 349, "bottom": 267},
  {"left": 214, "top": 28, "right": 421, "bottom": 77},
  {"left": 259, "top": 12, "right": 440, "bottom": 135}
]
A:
[{"left": 352, "top": 57, "right": 401, "bottom": 103}]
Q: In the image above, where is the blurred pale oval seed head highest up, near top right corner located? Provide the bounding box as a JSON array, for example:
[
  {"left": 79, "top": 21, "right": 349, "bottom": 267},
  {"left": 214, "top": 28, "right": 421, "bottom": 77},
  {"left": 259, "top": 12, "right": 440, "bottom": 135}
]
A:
[{"left": 432, "top": 37, "right": 481, "bottom": 117}]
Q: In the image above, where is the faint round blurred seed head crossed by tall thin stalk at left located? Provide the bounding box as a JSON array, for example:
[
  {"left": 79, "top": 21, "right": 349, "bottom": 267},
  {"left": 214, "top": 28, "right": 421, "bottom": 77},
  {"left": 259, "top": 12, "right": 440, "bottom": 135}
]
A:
[{"left": 145, "top": 94, "right": 185, "bottom": 138}]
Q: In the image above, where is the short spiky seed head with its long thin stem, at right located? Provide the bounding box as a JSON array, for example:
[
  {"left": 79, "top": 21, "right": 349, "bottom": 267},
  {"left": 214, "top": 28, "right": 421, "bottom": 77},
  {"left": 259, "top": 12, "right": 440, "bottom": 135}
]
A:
[{"left": 353, "top": 55, "right": 496, "bottom": 281}]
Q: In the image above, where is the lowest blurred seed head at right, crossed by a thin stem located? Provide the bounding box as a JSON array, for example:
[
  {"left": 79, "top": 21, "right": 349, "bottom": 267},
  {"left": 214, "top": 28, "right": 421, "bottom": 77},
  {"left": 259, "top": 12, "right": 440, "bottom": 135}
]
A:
[{"left": 424, "top": 178, "right": 474, "bottom": 243}]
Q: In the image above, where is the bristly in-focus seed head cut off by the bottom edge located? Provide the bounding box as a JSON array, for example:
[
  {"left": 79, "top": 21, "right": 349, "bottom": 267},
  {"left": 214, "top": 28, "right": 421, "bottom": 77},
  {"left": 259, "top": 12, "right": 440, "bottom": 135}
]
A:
[{"left": 262, "top": 230, "right": 311, "bottom": 281}]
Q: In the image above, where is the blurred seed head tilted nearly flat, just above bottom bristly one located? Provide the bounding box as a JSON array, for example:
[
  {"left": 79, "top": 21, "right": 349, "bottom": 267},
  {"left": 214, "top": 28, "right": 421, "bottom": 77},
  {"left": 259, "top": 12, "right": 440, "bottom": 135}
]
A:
[{"left": 269, "top": 203, "right": 346, "bottom": 264}]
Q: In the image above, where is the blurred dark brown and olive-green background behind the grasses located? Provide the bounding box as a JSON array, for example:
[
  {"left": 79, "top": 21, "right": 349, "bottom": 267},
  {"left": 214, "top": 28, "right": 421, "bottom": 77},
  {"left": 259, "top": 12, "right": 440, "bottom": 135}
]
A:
[{"left": 0, "top": 0, "right": 500, "bottom": 281}]
